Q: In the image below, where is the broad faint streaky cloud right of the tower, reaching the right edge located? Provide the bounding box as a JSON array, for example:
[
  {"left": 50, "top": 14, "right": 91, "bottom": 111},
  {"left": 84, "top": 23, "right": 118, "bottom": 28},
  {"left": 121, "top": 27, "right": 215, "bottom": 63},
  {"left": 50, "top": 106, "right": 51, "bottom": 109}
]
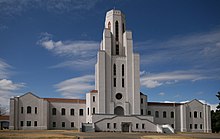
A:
[{"left": 135, "top": 29, "right": 220, "bottom": 68}]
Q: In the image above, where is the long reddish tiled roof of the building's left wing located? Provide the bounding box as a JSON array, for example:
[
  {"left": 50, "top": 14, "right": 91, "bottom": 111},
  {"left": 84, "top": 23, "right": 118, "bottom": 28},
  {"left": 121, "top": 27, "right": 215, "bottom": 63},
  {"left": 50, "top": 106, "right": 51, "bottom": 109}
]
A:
[{"left": 43, "top": 98, "right": 86, "bottom": 104}]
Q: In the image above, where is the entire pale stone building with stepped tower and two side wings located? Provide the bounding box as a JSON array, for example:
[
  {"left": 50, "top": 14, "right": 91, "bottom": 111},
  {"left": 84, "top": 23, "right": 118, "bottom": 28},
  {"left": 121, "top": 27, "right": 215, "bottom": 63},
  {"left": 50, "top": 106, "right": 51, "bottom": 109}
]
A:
[{"left": 10, "top": 10, "right": 211, "bottom": 133}]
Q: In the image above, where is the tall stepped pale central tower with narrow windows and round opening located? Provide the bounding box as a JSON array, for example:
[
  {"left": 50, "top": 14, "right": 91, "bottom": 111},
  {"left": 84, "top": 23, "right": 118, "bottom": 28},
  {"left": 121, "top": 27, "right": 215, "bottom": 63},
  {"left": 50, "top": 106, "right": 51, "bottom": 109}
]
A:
[{"left": 95, "top": 10, "right": 140, "bottom": 115}]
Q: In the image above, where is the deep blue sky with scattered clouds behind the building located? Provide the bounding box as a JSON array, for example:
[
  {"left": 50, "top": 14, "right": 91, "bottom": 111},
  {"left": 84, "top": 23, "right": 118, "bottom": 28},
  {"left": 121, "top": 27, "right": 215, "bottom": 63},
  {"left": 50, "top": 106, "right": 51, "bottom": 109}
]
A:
[{"left": 0, "top": 0, "right": 220, "bottom": 108}]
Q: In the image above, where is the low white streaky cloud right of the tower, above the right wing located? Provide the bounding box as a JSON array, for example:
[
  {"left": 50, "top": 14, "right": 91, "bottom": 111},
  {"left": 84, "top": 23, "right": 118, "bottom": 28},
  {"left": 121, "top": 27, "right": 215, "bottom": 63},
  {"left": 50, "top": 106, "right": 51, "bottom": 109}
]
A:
[{"left": 140, "top": 70, "right": 216, "bottom": 88}]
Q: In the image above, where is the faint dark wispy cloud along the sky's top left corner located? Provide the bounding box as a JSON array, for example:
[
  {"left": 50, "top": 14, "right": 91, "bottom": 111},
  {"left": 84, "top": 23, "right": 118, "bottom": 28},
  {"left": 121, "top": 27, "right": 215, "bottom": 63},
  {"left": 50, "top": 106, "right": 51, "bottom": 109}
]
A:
[{"left": 0, "top": 0, "right": 98, "bottom": 17}]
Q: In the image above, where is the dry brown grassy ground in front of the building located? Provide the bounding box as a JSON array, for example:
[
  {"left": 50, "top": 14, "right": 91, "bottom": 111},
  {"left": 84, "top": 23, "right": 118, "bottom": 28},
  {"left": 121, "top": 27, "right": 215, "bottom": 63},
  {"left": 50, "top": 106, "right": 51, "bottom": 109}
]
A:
[{"left": 0, "top": 130, "right": 220, "bottom": 139}]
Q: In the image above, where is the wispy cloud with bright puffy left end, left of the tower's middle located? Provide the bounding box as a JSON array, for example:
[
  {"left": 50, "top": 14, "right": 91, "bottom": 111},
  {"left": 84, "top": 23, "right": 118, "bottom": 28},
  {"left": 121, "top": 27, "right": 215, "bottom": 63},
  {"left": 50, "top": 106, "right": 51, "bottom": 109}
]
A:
[{"left": 37, "top": 32, "right": 99, "bottom": 69}]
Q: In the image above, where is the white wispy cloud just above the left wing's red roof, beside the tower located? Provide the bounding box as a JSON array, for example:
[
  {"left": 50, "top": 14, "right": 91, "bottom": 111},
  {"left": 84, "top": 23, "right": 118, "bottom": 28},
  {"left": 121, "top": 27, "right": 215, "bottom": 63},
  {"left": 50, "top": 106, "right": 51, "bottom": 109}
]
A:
[{"left": 55, "top": 75, "right": 95, "bottom": 98}]
